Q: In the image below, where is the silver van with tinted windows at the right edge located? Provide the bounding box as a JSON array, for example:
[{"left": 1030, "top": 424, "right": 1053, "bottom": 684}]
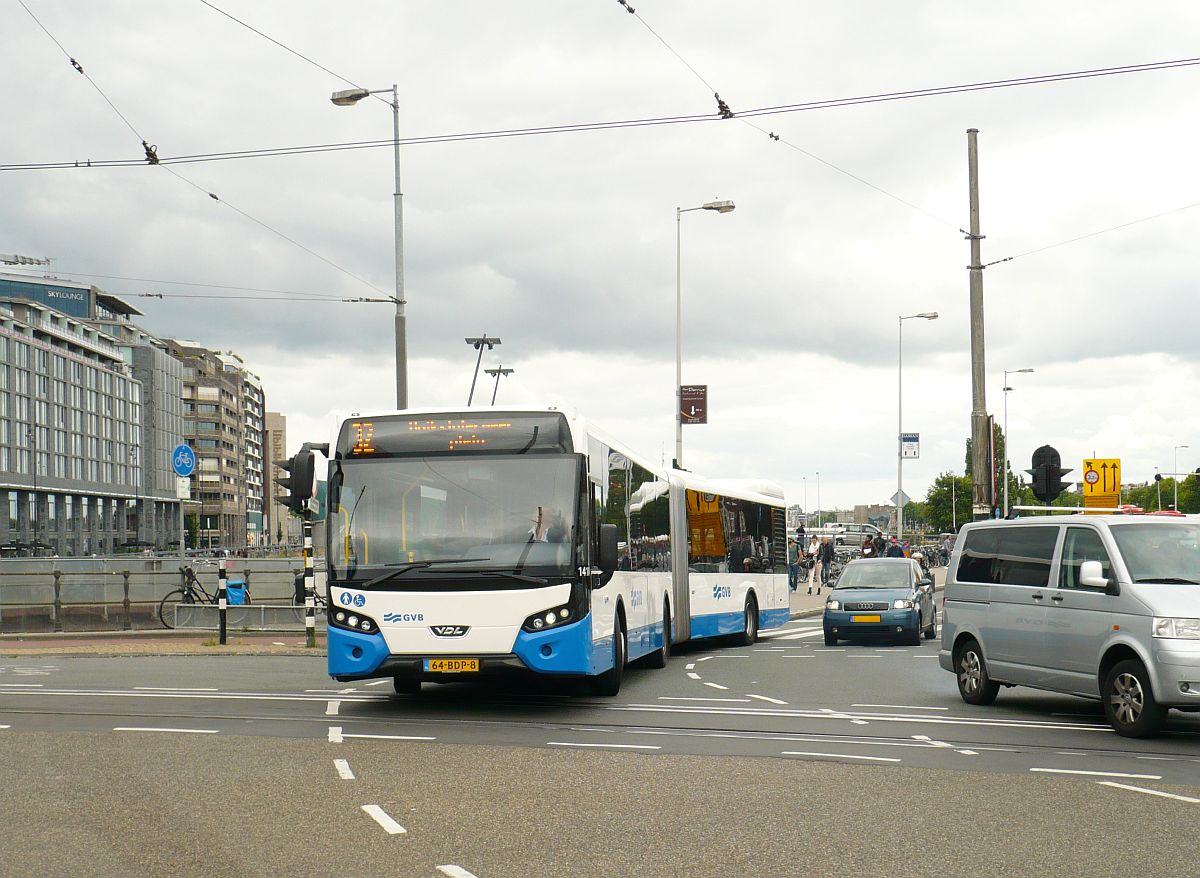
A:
[{"left": 938, "top": 515, "right": 1200, "bottom": 738}]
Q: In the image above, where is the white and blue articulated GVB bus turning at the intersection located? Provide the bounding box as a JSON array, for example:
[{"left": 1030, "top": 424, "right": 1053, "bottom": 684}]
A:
[{"left": 326, "top": 407, "right": 790, "bottom": 694}]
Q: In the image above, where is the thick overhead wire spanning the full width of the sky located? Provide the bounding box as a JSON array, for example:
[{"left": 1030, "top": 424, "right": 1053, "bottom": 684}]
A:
[{"left": 0, "top": 58, "right": 1200, "bottom": 170}]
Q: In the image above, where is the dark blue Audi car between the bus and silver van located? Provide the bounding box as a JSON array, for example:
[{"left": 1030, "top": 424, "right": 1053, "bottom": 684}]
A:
[{"left": 823, "top": 558, "right": 937, "bottom": 647}]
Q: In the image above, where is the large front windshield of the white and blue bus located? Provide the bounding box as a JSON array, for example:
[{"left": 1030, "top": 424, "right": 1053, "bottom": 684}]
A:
[{"left": 328, "top": 455, "right": 580, "bottom": 589}]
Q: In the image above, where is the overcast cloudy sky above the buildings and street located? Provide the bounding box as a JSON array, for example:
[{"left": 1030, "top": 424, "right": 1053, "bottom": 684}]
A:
[{"left": 0, "top": 0, "right": 1200, "bottom": 509}]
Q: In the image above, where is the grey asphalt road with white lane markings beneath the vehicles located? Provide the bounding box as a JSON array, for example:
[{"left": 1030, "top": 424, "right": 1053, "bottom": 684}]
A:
[{"left": 0, "top": 620, "right": 1200, "bottom": 878}]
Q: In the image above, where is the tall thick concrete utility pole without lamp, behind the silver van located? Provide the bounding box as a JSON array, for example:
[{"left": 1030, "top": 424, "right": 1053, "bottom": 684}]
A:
[{"left": 967, "top": 128, "right": 994, "bottom": 521}]
